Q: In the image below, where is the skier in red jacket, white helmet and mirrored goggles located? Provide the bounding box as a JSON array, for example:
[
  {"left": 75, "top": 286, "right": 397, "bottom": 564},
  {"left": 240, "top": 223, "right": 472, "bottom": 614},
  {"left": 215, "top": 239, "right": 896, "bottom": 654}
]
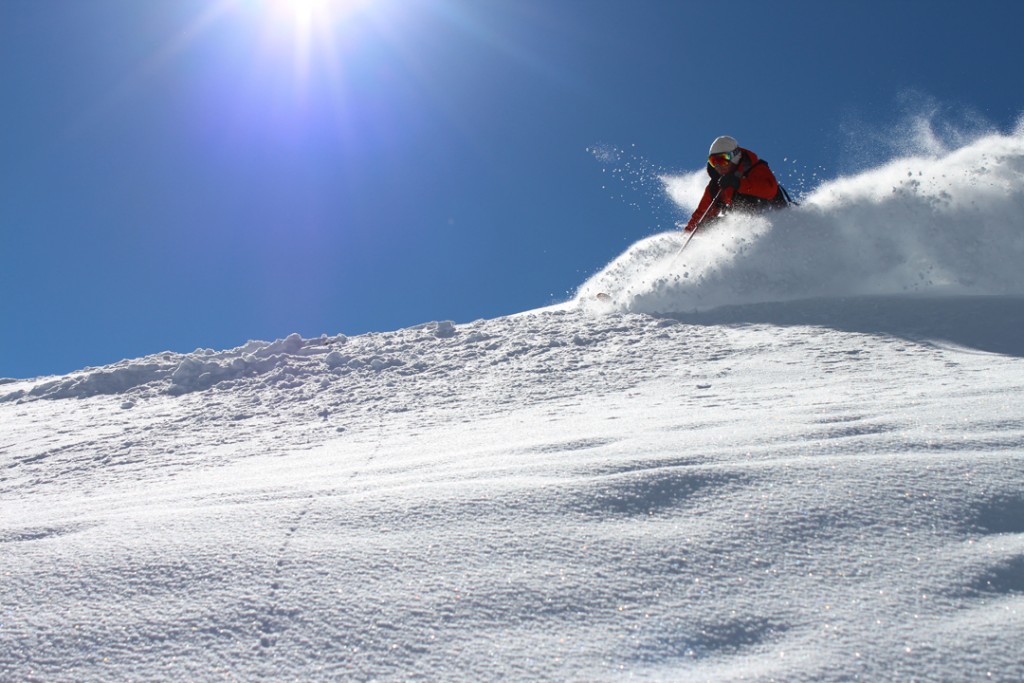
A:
[{"left": 684, "top": 135, "right": 788, "bottom": 232}]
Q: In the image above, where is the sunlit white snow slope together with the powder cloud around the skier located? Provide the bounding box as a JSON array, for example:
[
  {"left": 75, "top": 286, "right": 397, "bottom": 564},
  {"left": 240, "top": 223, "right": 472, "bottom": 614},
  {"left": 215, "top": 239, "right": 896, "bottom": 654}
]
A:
[{"left": 6, "top": 135, "right": 1024, "bottom": 682}]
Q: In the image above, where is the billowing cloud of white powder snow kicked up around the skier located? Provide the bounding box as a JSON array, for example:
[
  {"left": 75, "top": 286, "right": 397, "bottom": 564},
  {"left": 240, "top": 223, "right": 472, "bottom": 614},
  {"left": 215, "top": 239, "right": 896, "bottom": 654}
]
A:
[{"left": 577, "top": 124, "right": 1024, "bottom": 313}]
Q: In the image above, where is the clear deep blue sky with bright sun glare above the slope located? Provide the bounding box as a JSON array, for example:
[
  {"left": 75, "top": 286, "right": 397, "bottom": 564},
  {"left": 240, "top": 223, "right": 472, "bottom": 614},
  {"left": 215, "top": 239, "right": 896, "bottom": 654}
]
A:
[{"left": 0, "top": 0, "right": 1024, "bottom": 377}]
